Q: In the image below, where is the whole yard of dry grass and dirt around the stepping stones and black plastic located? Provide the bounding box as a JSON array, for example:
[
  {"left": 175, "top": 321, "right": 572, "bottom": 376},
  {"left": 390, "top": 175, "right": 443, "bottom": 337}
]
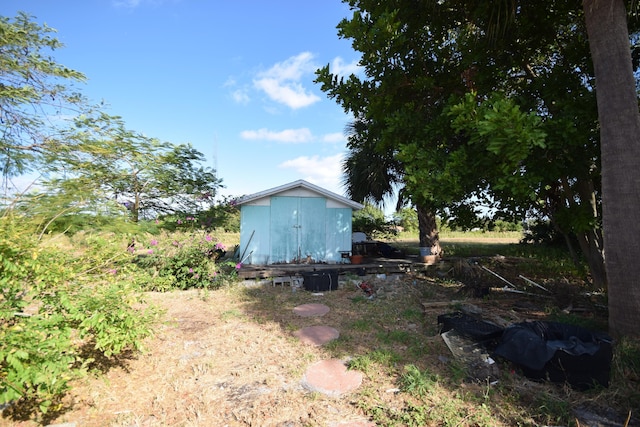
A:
[{"left": 0, "top": 237, "right": 640, "bottom": 427}]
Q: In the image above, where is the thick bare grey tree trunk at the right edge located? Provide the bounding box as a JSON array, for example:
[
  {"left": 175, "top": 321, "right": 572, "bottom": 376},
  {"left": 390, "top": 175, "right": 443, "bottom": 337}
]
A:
[{"left": 583, "top": 0, "right": 640, "bottom": 337}]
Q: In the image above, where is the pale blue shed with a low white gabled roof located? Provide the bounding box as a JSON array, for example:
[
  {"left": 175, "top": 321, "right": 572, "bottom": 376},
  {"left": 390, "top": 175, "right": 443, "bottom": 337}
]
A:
[{"left": 237, "top": 180, "right": 363, "bottom": 265}]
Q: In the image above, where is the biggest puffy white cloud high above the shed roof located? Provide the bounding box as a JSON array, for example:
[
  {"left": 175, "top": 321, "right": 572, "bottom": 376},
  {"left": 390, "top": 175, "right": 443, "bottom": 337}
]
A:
[{"left": 253, "top": 52, "right": 320, "bottom": 110}]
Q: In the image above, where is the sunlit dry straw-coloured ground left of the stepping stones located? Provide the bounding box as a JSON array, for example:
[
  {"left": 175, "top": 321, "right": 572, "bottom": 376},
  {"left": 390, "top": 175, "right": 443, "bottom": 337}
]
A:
[{"left": 50, "top": 286, "right": 384, "bottom": 427}]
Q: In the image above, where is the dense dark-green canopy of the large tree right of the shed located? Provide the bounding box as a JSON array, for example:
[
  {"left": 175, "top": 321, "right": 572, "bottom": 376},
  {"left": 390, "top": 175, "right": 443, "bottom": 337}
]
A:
[{"left": 317, "top": 0, "right": 632, "bottom": 286}]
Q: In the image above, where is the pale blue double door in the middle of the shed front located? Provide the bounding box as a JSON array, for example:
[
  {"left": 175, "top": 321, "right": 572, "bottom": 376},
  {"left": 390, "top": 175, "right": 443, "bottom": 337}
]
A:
[{"left": 271, "top": 197, "right": 326, "bottom": 262}]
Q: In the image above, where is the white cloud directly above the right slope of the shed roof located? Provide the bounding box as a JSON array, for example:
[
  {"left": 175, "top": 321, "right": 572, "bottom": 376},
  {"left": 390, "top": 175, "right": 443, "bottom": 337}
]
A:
[{"left": 278, "top": 153, "right": 344, "bottom": 194}]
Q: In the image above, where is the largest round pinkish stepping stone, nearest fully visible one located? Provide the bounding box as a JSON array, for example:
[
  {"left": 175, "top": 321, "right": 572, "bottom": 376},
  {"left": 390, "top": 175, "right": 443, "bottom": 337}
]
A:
[{"left": 302, "top": 359, "right": 363, "bottom": 397}]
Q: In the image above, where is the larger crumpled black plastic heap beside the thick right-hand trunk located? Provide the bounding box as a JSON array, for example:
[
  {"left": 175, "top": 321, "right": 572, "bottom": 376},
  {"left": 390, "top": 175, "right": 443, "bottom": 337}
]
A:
[{"left": 495, "top": 321, "right": 613, "bottom": 390}]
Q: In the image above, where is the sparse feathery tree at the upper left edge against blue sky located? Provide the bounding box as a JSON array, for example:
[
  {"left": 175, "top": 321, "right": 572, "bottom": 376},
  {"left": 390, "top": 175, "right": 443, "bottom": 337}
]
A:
[{"left": 0, "top": 13, "right": 88, "bottom": 186}]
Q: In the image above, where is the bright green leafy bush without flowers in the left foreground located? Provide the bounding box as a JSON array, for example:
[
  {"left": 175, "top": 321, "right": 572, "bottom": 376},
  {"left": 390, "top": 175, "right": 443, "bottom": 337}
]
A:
[{"left": 0, "top": 213, "right": 154, "bottom": 413}]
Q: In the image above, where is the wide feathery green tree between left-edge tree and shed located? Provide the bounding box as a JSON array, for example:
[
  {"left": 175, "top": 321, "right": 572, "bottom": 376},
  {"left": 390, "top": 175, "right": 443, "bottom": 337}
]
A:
[{"left": 46, "top": 114, "right": 222, "bottom": 222}]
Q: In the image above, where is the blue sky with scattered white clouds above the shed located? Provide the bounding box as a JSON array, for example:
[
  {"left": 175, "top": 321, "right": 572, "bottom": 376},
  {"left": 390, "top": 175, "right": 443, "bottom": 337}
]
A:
[{"left": 0, "top": 0, "right": 359, "bottom": 202}]
